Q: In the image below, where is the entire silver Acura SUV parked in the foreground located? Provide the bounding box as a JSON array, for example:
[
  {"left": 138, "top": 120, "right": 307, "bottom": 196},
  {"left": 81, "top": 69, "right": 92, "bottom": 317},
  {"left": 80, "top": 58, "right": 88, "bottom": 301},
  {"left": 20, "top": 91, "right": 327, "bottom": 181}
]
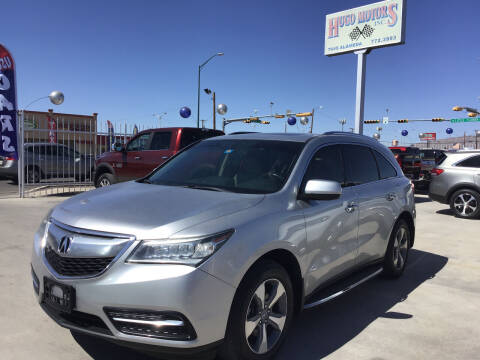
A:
[{"left": 32, "top": 132, "right": 415, "bottom": 359}]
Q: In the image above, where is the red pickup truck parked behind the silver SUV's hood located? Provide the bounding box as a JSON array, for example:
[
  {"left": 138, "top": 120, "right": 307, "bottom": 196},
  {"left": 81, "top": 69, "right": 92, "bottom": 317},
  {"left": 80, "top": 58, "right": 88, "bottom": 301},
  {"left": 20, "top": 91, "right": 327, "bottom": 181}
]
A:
[{"left": 94, "top": 128, "right": 224, "bottom": 187}]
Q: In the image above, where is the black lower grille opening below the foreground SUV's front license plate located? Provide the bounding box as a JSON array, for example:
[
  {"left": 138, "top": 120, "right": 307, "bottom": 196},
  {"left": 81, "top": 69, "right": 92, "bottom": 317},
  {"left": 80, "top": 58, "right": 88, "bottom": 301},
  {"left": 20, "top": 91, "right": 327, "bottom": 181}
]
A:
[{"left": 41, "top": 302, "right": 112, "bottom": 335}]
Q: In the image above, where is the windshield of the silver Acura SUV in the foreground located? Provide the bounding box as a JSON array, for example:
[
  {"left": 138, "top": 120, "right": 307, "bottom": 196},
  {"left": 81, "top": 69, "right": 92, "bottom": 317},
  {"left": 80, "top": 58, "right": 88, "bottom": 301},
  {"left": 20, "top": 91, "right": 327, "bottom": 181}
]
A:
[{"left": 145, "top": 140, "right": 304, "bottom": 194}]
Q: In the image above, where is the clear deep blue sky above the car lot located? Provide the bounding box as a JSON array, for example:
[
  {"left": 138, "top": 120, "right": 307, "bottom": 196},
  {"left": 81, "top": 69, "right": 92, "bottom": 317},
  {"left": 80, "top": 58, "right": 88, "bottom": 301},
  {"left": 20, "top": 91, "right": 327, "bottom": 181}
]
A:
[{"left": 0, "top": 0, "right": 480, "bottom": 143}]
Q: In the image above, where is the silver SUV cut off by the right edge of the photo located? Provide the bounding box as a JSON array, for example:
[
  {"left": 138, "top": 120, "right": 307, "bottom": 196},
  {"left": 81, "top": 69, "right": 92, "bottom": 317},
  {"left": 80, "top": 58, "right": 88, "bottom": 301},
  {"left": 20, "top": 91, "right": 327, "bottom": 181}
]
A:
[{"left": 429, "top": 150, "right": 480, "bottom": 219}]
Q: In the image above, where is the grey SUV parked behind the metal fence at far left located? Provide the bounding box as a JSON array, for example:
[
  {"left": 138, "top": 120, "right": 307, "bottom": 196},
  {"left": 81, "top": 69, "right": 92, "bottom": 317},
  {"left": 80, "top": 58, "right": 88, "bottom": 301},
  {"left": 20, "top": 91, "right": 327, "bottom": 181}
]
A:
[{"left": 0, "top": 143, "right": 94, "bottom": 184}]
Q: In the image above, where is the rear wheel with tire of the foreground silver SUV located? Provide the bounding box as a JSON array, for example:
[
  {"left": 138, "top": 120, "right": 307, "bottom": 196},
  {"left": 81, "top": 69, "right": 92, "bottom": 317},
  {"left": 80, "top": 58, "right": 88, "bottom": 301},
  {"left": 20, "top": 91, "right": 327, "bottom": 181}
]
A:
[{"left": 383, "top": 219, "right": 412, "bottom": 278}]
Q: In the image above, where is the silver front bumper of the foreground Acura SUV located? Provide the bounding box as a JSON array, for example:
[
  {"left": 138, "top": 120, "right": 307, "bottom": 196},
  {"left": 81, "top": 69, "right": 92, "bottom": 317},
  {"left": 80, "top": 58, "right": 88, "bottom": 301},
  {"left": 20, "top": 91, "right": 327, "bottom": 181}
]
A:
[{"left": 32, "top": 228, "right": 235, "bottom": 351}]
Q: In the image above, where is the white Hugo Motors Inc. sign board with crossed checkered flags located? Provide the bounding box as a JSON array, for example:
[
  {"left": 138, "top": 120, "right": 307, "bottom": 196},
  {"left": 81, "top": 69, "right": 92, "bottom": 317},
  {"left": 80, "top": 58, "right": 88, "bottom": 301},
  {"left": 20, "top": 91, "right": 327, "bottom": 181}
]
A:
[{"left": 325, "top": 0, "right": 405, "bottom": 55}]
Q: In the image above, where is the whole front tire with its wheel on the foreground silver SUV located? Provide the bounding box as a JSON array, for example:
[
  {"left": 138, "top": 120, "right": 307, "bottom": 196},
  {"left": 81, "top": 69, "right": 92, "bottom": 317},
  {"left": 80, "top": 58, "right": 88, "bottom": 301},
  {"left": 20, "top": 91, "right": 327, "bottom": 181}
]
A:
[{"left": 218, "top": 260, "right": 294, "bottom": 360}]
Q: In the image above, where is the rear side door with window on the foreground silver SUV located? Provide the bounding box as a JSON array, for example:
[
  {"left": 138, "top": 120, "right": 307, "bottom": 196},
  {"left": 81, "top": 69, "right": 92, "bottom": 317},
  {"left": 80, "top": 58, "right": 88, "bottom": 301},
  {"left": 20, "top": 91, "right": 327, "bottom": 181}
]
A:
[{"left": 343, "top": 145, "right": 400, "bottom": 264}]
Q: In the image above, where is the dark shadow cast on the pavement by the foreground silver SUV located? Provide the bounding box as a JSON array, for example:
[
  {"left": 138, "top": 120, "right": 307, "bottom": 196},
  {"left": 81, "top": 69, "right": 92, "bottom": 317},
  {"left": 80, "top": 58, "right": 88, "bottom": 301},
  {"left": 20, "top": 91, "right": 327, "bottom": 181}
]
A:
[{"left": 72, "top": 249, "right": 448, "bottom": 360}]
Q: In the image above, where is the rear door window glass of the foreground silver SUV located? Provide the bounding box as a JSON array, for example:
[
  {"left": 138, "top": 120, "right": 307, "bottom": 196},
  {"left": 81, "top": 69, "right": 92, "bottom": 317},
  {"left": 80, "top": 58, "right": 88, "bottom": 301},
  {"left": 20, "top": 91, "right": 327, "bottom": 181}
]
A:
[{"left": 343, "top": 145, "right": 378, "bottom": 186}]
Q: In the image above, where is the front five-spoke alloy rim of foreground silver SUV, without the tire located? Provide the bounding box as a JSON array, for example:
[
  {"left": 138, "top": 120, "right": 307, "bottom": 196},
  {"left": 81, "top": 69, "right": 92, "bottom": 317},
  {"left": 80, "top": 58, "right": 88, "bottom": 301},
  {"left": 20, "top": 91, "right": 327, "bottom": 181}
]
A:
[{"left": 245, "top": 279, "right": 287, "bottom": 354}]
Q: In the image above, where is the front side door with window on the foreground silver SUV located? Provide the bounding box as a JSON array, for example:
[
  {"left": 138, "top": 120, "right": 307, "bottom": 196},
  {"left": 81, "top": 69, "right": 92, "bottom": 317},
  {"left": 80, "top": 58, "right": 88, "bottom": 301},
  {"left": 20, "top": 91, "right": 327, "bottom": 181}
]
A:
[{"left": 302, "top": 145, "right": 358, "bottom": 292}]
